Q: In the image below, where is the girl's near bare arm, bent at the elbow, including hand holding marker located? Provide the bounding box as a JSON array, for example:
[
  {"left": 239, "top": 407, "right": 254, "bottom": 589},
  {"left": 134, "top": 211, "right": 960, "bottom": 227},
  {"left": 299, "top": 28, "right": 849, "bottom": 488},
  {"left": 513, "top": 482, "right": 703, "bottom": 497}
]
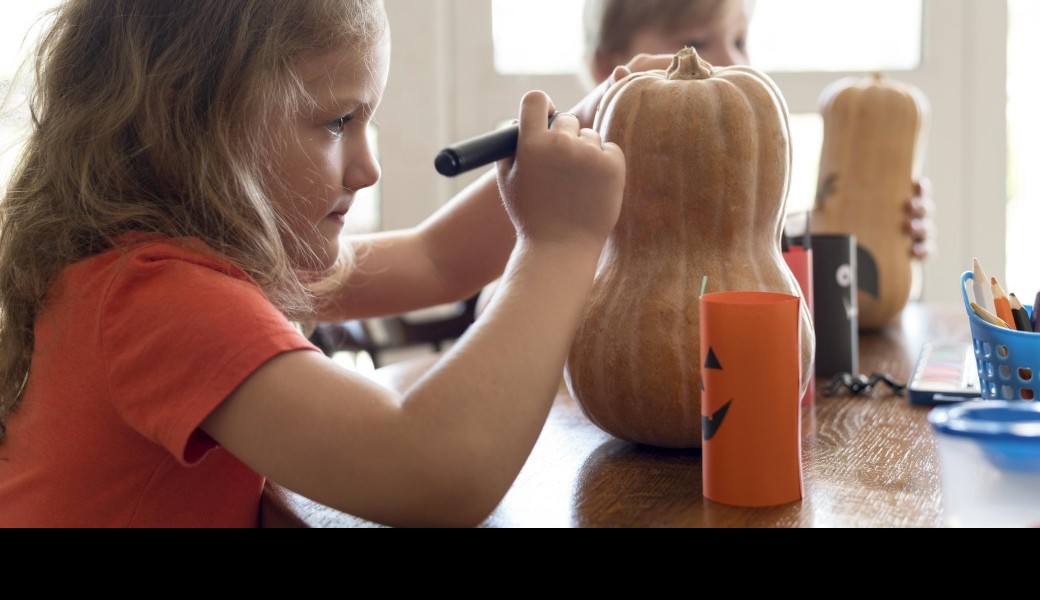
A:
[{"left": 203, "top": 93, "right": 624, "bottom": 525}]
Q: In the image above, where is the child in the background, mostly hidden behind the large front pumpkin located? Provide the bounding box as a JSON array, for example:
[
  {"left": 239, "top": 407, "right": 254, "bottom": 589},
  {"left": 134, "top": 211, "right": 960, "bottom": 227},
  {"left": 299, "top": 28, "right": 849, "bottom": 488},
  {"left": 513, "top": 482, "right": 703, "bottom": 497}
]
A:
[{"left": 584, "top": 0, "right": 935, "bottom": 259}]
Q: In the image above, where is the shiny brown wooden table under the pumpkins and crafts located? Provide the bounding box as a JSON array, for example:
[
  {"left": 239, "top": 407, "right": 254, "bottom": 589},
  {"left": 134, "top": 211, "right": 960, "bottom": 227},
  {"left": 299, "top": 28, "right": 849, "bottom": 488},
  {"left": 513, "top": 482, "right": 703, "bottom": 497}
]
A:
[{"left": 263, "top": 305, "right": 970, "bottom": 527}]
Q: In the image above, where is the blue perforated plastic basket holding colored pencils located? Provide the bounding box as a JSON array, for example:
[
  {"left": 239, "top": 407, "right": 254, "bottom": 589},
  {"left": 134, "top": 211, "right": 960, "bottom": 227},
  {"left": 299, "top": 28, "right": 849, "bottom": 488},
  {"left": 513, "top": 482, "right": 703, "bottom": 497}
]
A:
[{"left": 961, "top": 271, "right": 1040, "bottom": 400}]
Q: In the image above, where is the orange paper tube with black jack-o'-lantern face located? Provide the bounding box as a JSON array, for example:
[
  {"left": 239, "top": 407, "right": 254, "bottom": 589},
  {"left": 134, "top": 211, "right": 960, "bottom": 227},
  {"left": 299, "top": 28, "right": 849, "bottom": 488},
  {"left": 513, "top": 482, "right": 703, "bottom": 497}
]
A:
[{"left": 701, "top": 292, "right": 802, "bottom": 506}]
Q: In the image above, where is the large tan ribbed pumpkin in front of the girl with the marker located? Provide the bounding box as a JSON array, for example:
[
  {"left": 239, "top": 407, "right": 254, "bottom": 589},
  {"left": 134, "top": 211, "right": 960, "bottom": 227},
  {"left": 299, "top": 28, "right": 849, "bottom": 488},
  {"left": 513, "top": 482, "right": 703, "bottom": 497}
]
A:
[{"left": 565, "top": 49, "right": 815, "bottom": 448}]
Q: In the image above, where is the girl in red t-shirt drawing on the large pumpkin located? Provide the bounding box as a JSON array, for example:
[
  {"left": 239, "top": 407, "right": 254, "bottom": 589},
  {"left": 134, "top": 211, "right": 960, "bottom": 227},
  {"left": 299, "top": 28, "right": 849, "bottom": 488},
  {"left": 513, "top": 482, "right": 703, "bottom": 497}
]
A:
[{"left": 0, "top": 0, "right": 661, "bottom": 526}]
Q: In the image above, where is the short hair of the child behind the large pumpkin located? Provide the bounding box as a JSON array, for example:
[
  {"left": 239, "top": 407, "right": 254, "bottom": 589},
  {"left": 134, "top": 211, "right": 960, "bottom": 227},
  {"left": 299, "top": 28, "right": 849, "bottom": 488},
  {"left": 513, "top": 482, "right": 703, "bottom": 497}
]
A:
[{"left": 584, "top": 0, "right": 746, "bottom": 76}]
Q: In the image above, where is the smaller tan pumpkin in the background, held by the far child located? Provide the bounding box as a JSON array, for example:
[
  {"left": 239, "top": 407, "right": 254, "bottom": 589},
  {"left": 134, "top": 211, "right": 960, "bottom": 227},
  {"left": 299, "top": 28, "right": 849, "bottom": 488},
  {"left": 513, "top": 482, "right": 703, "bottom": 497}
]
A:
[{"left": 812, "top": 74, "right": 929, "bottom": 330}]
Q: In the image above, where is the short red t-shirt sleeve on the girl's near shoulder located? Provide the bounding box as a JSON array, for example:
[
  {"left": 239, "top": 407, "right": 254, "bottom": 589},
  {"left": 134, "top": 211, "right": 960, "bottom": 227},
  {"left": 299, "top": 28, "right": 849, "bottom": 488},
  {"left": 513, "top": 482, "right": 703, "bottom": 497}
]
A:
[{"left": 99, "top": 246, "right": 317, "bottom": 466}]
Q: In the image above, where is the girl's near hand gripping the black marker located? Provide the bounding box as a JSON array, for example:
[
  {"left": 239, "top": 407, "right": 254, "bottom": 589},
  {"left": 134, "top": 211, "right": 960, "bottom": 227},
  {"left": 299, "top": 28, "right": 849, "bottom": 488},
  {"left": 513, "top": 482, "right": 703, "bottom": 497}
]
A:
[{"left": 498, "top": 92, "right": 625, "bottom": 247}]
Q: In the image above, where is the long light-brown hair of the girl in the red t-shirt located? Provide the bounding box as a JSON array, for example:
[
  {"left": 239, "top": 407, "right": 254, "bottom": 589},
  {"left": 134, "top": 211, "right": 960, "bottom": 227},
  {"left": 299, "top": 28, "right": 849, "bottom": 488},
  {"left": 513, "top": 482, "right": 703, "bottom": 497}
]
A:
[{"left": 0, "top": 0, "right": 387, "bottom": 442}]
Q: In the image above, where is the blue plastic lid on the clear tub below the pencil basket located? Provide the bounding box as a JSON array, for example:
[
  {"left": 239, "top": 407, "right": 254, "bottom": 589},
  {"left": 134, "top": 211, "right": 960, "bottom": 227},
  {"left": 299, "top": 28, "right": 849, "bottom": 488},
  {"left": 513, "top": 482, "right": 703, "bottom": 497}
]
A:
[{"left": 928, "top": 400, "right": 1040, "bottom": 473}]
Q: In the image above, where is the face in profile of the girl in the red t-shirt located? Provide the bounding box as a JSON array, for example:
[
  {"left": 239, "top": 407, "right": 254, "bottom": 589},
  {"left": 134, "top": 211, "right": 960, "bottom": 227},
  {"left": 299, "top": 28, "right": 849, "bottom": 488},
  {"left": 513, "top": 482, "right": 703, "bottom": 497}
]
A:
[{"left": 277, "top": 36, "right": 390, "bottom": 270}]
